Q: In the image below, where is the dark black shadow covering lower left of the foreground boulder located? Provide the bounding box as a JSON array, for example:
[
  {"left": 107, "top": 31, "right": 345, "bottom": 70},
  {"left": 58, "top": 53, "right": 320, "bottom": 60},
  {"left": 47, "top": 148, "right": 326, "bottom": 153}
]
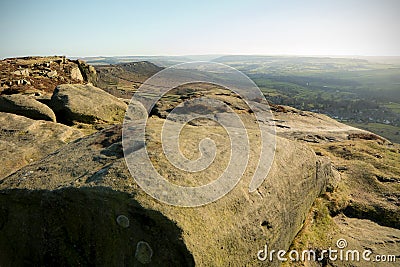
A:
[{"left": 0, "top": 187, "right": 194, "bottom": 266}]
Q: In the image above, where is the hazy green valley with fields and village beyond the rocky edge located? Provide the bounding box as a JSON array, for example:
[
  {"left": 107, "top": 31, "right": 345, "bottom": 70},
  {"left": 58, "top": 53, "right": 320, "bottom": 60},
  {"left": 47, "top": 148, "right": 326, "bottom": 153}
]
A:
[{"left": 217, "top": 56, "right": 400, "bottom": 143}]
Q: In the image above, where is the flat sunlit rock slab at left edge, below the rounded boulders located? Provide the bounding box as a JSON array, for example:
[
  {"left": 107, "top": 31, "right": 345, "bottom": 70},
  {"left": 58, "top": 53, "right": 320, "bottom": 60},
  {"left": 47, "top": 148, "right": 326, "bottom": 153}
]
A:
[{"left": 0, "top": 112, "right": 82, "bottom": 180}]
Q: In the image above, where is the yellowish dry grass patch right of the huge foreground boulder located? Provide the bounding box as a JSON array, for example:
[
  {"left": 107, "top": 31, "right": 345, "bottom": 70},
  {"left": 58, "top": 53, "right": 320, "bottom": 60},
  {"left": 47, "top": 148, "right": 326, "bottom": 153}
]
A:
[{"left": 284, "top": 138, "right": 400, "bottom": 266}]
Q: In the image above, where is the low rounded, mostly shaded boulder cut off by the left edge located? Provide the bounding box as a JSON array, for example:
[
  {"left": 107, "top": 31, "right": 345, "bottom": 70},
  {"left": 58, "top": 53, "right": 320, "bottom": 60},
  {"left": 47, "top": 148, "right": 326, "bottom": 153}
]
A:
[{"left": 0, "top": 94, "right": 56, "bottom": 122}]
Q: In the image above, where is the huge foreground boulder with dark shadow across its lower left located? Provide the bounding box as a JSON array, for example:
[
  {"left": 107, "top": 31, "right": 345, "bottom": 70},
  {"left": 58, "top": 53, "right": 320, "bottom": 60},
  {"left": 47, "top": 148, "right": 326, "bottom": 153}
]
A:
[{"left": 0, "top": 118, "right": 330, "bottom": 266}]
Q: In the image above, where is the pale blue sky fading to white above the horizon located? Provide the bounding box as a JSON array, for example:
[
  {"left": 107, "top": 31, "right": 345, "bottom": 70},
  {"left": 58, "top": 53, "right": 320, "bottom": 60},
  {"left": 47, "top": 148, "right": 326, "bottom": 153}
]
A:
[{"left": 0, "top": 0, "right": 400, "bottom": 58}]
